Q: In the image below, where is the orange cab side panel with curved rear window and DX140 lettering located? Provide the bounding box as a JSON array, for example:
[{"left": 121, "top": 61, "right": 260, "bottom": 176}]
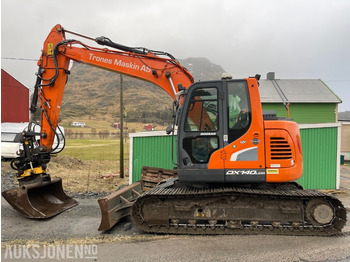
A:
[{"left": 223, "top": 78, "right": 266, "bottom": 182}]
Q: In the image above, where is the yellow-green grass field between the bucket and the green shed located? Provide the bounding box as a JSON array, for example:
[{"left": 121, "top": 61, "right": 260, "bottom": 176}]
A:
[{"left": 48, "top": 139, "right": 129, "bottom": 193}]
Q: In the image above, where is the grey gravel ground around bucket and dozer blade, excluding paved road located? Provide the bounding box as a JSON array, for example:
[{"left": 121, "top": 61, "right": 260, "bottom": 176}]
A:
[{"left": 1, "top": 162, "right": 350, "bottom": 241}]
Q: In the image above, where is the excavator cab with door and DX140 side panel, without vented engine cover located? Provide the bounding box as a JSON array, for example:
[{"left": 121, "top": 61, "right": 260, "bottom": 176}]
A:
[{"left": 178, "top": 75, "right": 265, "bottom": 182}]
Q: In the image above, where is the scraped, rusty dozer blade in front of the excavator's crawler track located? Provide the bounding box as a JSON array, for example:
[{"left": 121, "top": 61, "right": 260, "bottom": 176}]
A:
[{"left": 98, "top": 182, "right": 143, "bottom": 231}]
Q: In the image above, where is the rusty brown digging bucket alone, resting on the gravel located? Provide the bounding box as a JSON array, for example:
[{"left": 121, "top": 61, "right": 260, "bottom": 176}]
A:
[{"left": 2, "top": 178, "right": 78, "bottom": 219}]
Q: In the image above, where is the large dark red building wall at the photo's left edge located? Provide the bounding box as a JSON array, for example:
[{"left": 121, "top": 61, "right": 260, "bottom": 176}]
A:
[{"left": 1, "top": 69, "right": 29, "bottom": 123}]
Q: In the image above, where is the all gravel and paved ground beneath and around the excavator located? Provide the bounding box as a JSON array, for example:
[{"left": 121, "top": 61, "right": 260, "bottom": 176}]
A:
[{"left": 1, "top": 163, "right": 350, "bottom": 262}]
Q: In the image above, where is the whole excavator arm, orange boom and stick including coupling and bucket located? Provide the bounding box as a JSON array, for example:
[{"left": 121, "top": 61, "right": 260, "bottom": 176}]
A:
[{"left": 2, "top": 25, "right": 194, "bottom": 218}]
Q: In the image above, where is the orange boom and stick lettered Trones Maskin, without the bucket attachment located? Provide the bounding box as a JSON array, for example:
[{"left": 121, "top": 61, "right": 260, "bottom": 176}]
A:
[{"left": 37, "top": 25, "right": 194, "bottom": 151}]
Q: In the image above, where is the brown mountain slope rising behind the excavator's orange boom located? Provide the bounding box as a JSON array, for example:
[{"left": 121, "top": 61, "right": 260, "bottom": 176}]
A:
[{"left": 60, "top": 58, "right": 224, "bottom": 124}]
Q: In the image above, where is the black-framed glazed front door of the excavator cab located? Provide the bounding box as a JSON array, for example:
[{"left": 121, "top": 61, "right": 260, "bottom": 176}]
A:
[{"left": 177, "top": 81, "right": 224, "bottom": 182}]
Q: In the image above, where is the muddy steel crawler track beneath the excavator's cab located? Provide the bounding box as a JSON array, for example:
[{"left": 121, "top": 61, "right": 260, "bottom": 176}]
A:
[{"left": 132, "top": 187, "right": 346, "bottom": 236}]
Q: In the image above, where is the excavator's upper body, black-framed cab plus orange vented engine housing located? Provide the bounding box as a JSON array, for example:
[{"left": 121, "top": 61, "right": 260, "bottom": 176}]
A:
[{"left": 177, "top": 75, "right": 302, "bottom": 184}]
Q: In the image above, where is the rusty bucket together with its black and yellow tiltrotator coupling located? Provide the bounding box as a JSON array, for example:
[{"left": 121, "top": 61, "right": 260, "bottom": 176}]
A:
[{"left": 2, "top": 124, "right": 78, "bottom": 219}]
